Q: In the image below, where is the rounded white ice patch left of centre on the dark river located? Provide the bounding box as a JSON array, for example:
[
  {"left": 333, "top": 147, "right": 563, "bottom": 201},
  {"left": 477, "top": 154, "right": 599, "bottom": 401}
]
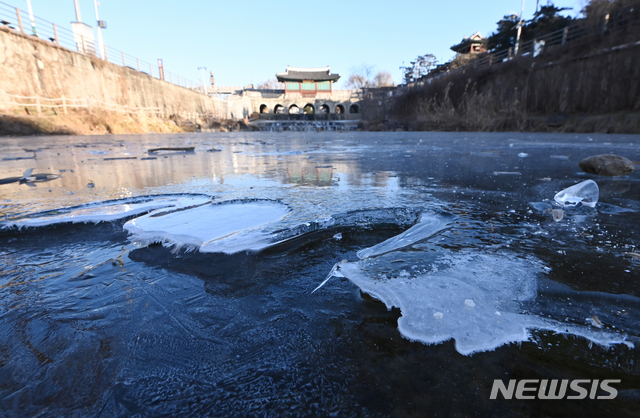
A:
[{"left": 124, "top": 200, "right": 289, "bottom": 254}]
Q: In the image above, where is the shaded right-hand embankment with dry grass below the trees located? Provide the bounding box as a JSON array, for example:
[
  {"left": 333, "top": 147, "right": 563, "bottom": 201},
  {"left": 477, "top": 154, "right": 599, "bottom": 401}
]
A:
[{"left": 384, "top": 11, "right": 640, "bottom": 133}]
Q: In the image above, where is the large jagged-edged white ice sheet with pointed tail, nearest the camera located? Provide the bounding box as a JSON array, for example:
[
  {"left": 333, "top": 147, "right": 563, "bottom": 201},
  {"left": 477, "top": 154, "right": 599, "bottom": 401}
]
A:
[{"left": 339, "top": 254, "right": 626, "bottom": 355}]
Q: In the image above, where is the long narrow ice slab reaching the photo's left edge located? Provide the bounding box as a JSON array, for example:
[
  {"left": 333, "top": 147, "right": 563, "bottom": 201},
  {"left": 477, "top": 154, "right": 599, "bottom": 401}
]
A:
[{"left": 0, "top": 195, "right": 211, "bottom": 228}]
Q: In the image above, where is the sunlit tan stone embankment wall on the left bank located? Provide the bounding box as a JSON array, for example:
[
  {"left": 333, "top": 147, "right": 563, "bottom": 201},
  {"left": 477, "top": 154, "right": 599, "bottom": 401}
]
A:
[{"left": 0, "top": 27, "right": 222, "bottom": 116}]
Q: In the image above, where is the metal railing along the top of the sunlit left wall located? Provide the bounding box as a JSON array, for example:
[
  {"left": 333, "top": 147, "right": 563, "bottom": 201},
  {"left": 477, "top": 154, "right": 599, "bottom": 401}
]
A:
[{"left": 0, "top": 1, "right": 203, "bottom": 93}]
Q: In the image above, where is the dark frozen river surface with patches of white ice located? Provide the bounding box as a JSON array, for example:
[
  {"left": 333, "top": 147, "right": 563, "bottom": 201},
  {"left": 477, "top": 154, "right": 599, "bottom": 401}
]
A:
[{"left": 0, "top": 132, "right": 640, "bottom": 417}]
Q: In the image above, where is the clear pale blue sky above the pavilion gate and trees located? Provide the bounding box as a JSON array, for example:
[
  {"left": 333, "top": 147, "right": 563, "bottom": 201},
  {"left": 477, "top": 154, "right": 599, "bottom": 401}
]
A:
[{"left": 18, "top": 0, "right": 586, "bottom": 88}]
